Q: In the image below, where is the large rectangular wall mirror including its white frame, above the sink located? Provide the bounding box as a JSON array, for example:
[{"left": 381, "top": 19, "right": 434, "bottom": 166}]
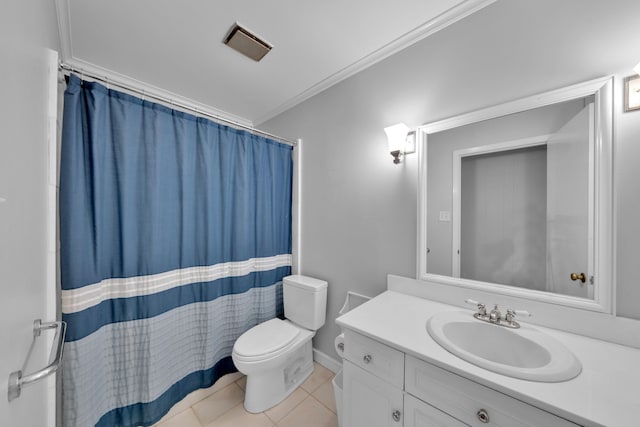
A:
[{"left": 417, "top": 78, "right": 614, "bottom": 313}]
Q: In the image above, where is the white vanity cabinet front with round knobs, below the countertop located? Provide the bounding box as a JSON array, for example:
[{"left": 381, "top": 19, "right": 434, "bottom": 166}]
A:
[{"left": 343, "top": 329, "right": 577, "bottom": 427}]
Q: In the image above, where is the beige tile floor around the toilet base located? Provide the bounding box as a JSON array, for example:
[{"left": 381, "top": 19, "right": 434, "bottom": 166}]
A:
[{"left": 154, "top": 363, "right": 338, "bottom": 427}]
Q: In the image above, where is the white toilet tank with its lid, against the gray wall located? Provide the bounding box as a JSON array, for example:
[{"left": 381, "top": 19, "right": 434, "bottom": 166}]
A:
[{"left": 282, "top": 275, "right": 327, "bottom": 331}]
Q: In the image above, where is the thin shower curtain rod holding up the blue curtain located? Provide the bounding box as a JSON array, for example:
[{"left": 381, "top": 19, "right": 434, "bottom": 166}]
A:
[{"left": 58, "top": 62, "right": 298, "bottom": 147}]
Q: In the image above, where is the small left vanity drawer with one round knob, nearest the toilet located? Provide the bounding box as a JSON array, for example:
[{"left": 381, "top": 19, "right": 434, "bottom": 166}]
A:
[{"left": 344, "top": 329, "right": 404, "bottom": 389}]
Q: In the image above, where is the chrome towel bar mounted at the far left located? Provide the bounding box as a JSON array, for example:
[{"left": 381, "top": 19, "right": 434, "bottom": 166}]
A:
[{"left": 8, "top": 319, "right": 67, "bottom": 402}]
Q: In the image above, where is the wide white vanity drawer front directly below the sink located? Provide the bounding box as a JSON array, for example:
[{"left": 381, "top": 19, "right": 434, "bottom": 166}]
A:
[{"left": 405, "top": 356, "right": 576, "bottom": 427}]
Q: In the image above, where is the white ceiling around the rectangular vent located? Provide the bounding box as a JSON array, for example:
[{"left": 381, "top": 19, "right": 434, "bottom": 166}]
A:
[{"left": 56, "top": 0, "right": 495, "bottom": 125}]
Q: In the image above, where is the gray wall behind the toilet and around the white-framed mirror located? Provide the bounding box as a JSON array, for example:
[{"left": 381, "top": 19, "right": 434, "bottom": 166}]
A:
[{"left": 261, "top": 0, "right": 640, "bottom": 357}]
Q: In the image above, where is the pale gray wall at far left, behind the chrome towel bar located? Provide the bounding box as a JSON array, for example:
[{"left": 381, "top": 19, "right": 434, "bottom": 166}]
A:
[{"left": 0, "top": 0, "right": 58, "bottom": 426}]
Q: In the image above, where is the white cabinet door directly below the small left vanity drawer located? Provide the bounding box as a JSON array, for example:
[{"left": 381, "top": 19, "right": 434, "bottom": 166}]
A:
[{"left": 342, "top": 360, "right": 404, "bottom": 427}]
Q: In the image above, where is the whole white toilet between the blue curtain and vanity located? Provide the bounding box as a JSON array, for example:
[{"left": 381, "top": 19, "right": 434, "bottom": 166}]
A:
[{"left": 232, "top": 275, "right": 327, "bottom": 413}]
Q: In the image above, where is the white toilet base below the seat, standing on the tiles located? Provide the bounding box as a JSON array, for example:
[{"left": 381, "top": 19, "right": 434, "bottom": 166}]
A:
[{"left": 244, "top": 339, "right": 313, "bottom": 414}]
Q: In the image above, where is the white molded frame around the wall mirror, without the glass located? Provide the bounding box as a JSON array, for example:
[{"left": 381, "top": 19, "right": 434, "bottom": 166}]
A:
[{"left": 416, "top": 76, "right": 615, "bottom": 314}]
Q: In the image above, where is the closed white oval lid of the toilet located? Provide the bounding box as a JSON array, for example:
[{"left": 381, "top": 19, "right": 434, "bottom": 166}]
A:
[{"left": 233, "top": 319, "right": 300, "bottom": 357}]
